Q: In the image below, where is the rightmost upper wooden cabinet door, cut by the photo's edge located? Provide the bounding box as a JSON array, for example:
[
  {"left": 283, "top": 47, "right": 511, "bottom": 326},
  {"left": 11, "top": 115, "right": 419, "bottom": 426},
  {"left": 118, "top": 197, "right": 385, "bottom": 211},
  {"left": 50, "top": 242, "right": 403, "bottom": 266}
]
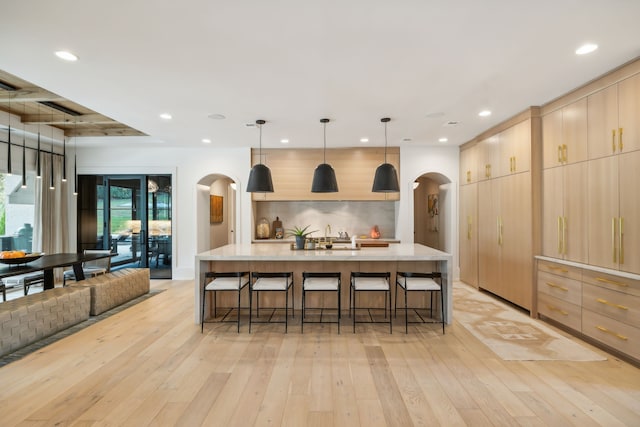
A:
[{"left": 618, "top": 74, "right": 640, "bottom": 153}]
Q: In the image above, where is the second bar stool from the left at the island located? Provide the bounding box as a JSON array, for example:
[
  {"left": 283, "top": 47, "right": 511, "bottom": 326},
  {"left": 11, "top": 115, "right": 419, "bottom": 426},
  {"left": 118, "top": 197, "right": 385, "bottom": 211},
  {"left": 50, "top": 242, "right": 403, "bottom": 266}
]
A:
[{"left": 249, "top": 271, "right": 295, "bottom": 334}]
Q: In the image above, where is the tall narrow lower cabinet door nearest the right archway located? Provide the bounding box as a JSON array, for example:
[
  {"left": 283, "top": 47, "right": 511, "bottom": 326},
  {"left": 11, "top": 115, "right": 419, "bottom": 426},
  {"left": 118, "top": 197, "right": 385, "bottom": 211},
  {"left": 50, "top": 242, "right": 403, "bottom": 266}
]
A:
[{"left": 459, "top": 184, "right": 478, "bottom": 287}]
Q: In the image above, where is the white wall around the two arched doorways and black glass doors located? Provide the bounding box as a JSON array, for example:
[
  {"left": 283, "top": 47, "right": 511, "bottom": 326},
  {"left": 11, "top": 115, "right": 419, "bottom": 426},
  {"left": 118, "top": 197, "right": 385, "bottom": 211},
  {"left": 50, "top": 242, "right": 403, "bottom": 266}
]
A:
[{"left": 69, "top": 145, "right": 459, "bottom": 280}]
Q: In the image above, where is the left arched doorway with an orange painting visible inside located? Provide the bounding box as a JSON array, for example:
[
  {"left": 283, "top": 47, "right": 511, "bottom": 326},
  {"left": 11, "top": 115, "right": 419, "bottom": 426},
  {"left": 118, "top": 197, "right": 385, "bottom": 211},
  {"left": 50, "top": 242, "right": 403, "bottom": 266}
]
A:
[{"left": 196, "top": 174, "right": 237, "bottom": 253}]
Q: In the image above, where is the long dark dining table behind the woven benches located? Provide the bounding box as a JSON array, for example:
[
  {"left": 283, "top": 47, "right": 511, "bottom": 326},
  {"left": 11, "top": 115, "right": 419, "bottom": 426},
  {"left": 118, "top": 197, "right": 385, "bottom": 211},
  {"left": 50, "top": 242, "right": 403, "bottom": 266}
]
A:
[{"left": 0, "top": 253, "right": 110, "bottom": 290}]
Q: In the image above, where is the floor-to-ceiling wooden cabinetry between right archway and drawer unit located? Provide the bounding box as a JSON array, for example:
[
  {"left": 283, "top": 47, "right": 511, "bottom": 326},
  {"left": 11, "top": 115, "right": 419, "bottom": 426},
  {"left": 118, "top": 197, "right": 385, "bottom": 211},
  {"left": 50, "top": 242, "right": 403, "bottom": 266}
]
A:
[{"left": 460, "top": 109, "right": 539, "bottom": 310}]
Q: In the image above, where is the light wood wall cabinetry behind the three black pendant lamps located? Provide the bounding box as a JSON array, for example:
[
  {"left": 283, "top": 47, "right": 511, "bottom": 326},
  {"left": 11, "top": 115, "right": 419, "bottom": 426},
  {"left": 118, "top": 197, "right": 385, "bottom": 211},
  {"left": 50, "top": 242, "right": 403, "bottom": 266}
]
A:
[{"left": 252, "top": 147, "right": 400, "bottom": 201}]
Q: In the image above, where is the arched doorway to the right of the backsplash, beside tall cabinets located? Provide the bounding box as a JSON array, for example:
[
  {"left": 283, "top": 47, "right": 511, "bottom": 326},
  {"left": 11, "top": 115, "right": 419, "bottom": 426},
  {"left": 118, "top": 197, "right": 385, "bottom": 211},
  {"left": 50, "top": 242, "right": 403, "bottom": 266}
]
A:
[{"left": 413, "top": 172, "right": 453, "bottom": 253}]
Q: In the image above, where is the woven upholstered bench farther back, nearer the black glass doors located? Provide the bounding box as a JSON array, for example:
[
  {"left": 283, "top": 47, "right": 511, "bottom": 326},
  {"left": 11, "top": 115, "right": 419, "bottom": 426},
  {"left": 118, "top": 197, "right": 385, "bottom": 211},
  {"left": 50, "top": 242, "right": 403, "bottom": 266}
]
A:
[{"left": 70, "top": 268, "right": 150, "bottom": 316}]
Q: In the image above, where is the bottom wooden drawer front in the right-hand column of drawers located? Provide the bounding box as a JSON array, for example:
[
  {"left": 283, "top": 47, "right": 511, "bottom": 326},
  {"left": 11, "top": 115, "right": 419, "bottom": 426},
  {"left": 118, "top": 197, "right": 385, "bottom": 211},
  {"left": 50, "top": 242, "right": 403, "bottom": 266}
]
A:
[{"left": 582, "top": 310, "right": 640, "bottom": 360}]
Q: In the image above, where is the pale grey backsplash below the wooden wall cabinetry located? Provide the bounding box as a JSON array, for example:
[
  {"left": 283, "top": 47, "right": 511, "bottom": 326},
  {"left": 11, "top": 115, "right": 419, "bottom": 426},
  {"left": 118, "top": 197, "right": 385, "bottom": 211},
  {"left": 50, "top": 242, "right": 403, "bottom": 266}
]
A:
[{"left": 254, "top": 201, "right": 397, "bottom": 239}]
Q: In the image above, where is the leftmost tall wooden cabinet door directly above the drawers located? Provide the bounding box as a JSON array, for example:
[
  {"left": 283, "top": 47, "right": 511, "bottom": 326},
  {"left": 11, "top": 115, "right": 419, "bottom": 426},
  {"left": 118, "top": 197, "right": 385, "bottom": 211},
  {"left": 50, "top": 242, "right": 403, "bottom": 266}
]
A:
[{"left": 542, "top": 166, "right": 564, "bottom": 258}]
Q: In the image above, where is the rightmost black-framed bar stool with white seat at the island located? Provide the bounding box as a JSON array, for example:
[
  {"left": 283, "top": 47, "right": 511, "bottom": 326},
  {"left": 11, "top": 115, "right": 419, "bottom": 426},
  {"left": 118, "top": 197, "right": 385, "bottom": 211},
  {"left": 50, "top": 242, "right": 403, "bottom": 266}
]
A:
[{"left": 395, "top": 271, "right": 445, "bottom": 335}]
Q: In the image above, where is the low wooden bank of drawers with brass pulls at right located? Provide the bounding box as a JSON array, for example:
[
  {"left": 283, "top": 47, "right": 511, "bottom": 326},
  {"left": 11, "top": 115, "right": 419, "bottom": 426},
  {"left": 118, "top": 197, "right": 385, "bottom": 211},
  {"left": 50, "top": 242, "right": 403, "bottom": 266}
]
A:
[{"left": 537, "top": 258, "right": 640, "bottom": 360}]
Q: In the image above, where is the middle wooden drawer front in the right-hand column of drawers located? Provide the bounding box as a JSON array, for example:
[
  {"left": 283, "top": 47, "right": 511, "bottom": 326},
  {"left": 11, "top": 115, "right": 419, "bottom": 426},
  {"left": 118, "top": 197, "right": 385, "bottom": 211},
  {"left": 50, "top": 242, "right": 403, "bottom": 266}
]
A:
[{"left": 582, "top": 283, "right": 640, "bottom": 326}]
